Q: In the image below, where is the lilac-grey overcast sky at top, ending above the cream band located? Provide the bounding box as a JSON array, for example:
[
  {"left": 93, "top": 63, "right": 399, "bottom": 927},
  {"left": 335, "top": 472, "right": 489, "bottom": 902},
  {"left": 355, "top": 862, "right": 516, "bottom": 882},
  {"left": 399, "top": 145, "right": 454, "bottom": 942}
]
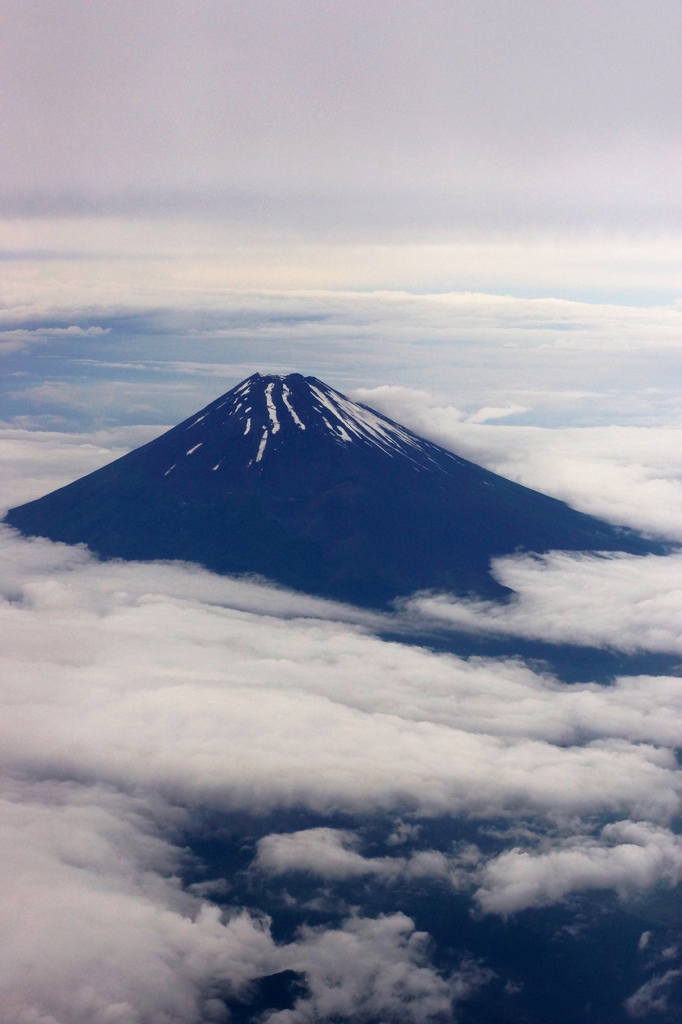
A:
[{"left": 2, "top": 0, "right": 682, "bottom": 222}]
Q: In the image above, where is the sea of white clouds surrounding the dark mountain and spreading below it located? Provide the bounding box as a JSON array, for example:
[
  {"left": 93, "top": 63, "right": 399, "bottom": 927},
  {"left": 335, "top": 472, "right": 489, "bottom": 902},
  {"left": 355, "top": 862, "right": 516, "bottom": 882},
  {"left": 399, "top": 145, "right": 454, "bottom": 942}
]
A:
[{"left": 0, "top": 397, "right": 682, "bottom": 1024}]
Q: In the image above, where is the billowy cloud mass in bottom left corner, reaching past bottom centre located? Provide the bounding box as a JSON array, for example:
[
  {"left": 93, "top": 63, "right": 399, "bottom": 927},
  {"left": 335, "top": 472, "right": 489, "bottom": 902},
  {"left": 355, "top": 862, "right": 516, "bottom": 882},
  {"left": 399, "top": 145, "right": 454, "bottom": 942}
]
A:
[{"left": 0, "top": 779, "right": 483, "bottom": 1024}]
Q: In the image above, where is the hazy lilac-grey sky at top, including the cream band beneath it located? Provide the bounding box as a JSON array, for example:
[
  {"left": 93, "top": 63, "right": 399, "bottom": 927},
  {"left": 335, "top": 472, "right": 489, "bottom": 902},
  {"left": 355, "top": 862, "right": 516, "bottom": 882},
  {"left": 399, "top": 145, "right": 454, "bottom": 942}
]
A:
[{"left": 0, "top": 0, "right": 682, "bottom": 297}]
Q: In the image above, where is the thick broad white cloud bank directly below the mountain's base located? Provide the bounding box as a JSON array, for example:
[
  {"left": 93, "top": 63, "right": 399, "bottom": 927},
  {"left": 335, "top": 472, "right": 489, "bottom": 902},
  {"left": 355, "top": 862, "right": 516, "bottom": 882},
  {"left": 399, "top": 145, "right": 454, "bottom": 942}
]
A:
[{"left": 1, "top": 538, "right": 679, "bottom": 817}]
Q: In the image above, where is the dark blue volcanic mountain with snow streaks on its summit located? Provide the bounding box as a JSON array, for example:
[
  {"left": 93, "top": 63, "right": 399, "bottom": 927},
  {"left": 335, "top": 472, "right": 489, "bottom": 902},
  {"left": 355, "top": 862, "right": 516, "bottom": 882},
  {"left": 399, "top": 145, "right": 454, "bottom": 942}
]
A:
[{"left": 6, "top": 374, "right": 663, "bottom": 607}]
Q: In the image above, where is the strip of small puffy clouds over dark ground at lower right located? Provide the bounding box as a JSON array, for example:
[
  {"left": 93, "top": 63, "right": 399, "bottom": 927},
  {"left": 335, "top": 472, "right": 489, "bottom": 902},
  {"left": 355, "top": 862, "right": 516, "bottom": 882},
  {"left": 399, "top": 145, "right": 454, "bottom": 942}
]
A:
[{"left": 253, "top": 820, "right": 682, "bottom": 921}]
